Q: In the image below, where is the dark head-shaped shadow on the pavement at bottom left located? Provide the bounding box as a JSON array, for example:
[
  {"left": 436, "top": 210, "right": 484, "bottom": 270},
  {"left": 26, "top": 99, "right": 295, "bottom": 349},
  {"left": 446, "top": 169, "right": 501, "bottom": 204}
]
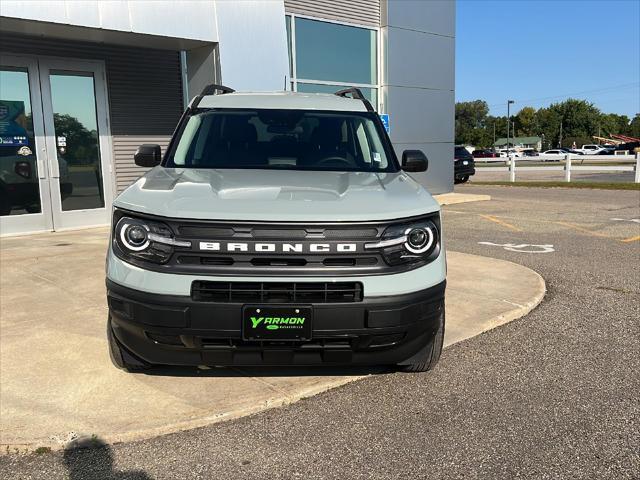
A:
[{"left": 63, "top": 437, "right": 152, "bottom": 480}]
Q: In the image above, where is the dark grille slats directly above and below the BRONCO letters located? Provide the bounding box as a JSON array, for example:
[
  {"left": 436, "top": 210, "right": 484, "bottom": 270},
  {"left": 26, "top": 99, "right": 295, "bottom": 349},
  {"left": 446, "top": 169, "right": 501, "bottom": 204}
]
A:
[{"left": 167, "top": 220, "right": 390, "bottom": 276}]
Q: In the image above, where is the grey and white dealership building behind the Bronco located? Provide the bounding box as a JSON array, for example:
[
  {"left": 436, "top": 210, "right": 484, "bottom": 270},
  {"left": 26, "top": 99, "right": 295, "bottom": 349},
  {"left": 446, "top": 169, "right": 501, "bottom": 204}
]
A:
[{"left": 0, "top": 0, "right": 455, "bottom": 235}]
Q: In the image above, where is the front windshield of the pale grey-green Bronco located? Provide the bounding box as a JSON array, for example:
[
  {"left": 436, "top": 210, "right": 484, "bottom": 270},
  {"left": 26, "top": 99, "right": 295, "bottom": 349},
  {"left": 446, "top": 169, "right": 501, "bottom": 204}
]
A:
[{"left": 165, "top": 110, "right": 397, "bottom": 172}]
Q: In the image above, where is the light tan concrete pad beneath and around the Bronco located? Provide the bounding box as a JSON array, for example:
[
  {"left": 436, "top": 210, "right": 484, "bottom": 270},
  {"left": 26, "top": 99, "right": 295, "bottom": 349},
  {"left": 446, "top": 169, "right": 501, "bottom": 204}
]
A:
[{"left": 0, "top": 228, "right": 545, "bottom": 452}]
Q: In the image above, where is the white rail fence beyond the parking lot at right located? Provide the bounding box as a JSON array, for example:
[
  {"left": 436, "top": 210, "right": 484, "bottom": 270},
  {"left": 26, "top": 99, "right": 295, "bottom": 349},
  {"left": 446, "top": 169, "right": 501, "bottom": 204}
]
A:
[{"left": 475, "top": 153, "right": 640, "bottom": 183}]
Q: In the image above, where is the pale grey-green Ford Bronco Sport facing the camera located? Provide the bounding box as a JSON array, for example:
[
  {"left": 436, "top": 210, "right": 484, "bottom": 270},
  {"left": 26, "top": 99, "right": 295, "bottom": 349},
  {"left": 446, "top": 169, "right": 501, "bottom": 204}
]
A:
[{"left": 106, "top": 85, "right": 446, "bottom": 371}]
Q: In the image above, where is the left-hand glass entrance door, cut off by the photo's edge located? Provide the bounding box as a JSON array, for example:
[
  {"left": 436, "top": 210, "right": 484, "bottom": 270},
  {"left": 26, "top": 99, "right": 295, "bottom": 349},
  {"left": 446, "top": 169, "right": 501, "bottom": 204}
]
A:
[{"left": 0, "top": 54, "right": 53, "bottom": 235}]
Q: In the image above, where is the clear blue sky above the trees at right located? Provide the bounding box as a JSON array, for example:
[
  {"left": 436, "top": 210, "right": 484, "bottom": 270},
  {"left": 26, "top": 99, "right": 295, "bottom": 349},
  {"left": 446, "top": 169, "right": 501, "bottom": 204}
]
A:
[{"left": 456, "top": 0, "right": 640, "bottom": 117}]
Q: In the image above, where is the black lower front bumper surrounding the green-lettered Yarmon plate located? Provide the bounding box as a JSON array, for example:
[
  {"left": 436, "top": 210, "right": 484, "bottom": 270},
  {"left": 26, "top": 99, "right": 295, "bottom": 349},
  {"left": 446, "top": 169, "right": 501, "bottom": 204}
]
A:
[{"left": 107, "top": 280, "right": 445, "bottom": 365}]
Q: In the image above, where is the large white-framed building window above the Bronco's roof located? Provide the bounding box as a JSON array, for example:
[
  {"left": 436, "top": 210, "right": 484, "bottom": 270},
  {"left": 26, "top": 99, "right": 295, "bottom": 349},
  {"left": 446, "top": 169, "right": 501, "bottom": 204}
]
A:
[{"left": 286, "top": 15, "right": 378, "bottom": 106}]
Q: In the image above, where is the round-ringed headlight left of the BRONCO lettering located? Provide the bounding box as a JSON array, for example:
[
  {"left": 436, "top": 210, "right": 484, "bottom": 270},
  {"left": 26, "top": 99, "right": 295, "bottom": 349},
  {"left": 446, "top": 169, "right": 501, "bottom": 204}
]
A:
[{"left": 113, "top": 211, "right": 191, "bottom": 263}]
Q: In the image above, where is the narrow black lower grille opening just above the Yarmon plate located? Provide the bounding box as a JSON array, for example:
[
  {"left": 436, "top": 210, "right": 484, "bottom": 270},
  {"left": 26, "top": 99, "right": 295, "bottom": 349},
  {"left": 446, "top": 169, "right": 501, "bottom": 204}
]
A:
[{"left": 191, "top": 280, "right": 363, "bottom": 303}]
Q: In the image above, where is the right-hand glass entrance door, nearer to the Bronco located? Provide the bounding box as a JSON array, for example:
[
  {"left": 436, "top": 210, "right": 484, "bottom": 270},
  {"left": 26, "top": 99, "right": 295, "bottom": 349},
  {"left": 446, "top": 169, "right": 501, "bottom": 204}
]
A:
[{"left": 39, "top": 59, "right": 112, "bottom": 230}]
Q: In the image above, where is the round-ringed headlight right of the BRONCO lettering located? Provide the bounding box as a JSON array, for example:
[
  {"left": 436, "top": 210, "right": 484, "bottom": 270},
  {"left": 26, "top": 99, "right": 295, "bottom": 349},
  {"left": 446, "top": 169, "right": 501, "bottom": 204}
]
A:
[{"left": 365, "top": 220, "right": 440, "bottom": 265}]
